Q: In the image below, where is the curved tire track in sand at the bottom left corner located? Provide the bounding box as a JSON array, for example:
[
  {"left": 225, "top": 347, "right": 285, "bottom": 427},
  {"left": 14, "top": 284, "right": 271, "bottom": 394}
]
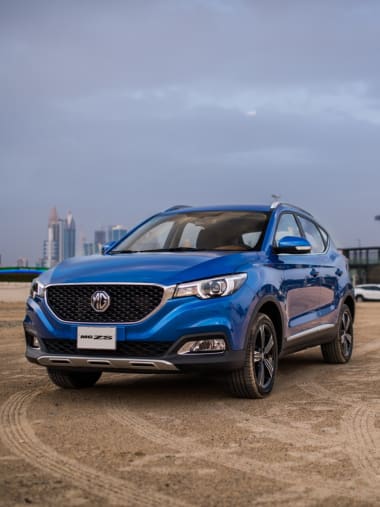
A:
[{"left": 0, "top": 389, "right": 190, "bottom": 507}]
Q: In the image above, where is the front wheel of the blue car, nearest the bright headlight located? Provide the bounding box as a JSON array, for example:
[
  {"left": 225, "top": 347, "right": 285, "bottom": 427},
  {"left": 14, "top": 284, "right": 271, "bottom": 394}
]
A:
[{"left": 228, "top": 313, "right": 278, "bottom": 398}]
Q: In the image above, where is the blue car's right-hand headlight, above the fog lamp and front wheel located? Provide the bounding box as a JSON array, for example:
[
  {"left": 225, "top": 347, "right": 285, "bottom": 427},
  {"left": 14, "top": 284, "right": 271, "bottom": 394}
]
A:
[{"left": 173, "top": 273, "right": 247, "bottom": 299}]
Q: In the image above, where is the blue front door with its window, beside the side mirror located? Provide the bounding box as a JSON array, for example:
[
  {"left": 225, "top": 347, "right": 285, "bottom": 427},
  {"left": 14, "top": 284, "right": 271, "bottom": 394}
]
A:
[{"left": 274, "top": 212, "right": 320, "bottom": 340}]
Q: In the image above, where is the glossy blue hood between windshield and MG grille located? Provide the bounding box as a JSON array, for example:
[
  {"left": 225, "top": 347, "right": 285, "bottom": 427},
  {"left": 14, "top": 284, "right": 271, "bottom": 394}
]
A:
[{"left": 40, "top": 252, "right": 259, "bottom": 285}]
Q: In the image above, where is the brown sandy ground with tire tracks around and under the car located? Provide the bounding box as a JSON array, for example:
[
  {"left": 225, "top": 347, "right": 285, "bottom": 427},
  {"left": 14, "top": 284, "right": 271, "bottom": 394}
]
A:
[{"left": 0, "top": 298, "right": 380, "bottom": 507}]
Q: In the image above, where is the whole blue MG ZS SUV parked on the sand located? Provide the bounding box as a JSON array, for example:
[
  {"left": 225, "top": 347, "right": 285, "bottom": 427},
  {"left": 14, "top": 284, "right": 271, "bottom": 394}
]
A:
[{"left": 24, "top": 203, "right": 355, "bottom": 398}]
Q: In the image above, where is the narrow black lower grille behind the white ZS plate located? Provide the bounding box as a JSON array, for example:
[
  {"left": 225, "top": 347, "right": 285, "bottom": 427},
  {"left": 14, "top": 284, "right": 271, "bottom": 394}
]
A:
[{"left": 42, "top": 339, "right": 172, "bottom": 357}]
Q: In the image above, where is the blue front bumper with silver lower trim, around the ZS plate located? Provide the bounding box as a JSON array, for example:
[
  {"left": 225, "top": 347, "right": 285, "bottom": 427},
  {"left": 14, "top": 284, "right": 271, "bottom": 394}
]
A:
[{"left": 24, "top": 285, "right": 252, "bottom": 373}]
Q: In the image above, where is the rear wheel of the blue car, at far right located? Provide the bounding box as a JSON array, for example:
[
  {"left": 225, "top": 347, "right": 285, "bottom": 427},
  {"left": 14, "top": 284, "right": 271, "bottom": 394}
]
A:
[{"left": 321, "top": 305, "right": 354, "bottom": 364}]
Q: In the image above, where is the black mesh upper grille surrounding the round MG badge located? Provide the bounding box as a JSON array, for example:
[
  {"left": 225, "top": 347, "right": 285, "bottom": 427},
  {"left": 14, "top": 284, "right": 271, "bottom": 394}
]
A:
[{"left": 46, "top": 284, "right": 164, "bottom": 323}]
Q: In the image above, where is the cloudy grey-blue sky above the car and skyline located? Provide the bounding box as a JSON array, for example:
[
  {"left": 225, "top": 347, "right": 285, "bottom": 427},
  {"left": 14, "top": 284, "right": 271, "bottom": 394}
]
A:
[{"left": 0, "top": 0, "right": 380, "bottom": 265}]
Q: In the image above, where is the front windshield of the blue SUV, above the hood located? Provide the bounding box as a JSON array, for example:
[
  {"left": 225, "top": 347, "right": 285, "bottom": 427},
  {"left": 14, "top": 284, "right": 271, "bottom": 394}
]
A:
[{"left": 110, "top": 211, "right": 268, "bottom": 254}]
